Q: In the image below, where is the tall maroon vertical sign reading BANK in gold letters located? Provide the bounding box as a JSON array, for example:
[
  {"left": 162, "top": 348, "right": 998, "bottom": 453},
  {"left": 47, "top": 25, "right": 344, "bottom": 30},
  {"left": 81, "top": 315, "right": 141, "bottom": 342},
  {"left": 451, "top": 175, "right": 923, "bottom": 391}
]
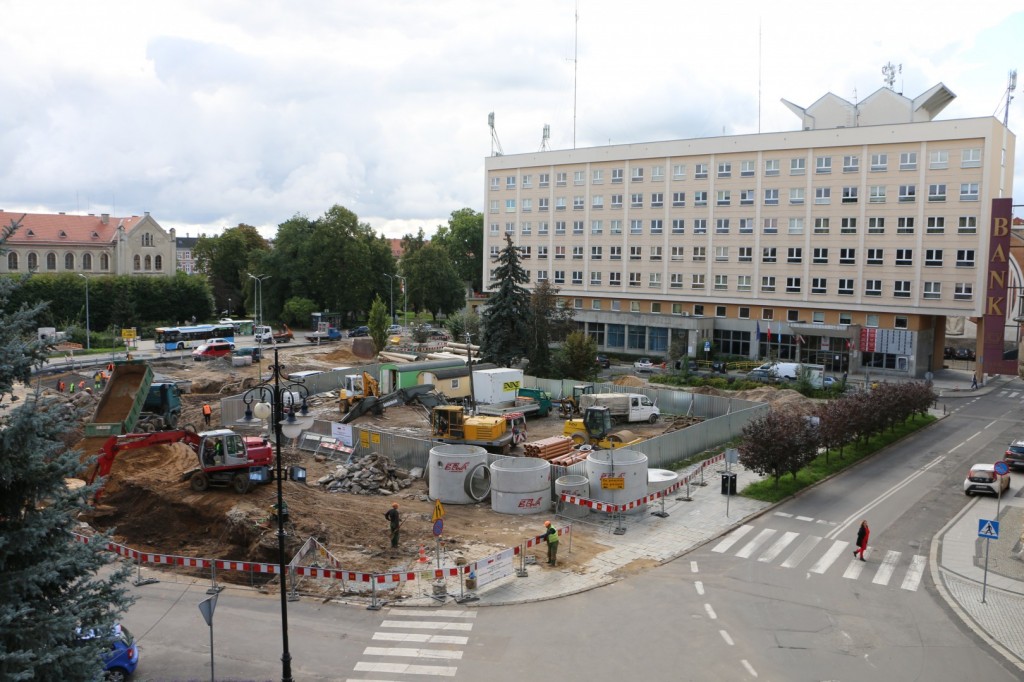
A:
[{"left": 978, "top": 199, "right": 1017, "bottom": 376}]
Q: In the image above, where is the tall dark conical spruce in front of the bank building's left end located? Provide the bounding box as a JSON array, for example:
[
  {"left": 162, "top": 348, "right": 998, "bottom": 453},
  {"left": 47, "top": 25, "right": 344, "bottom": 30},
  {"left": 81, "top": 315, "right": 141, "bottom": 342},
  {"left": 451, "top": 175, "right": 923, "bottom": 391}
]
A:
[{"left": 480, "top": 235, "right": 530, "bottom": 367}]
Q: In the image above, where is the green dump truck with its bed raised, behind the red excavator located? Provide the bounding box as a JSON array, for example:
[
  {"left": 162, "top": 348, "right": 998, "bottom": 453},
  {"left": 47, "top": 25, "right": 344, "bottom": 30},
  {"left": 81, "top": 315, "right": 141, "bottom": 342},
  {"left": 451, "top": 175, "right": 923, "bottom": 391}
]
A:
[{"left": 85, "top": 360, "right": 181, "bottom": 437}]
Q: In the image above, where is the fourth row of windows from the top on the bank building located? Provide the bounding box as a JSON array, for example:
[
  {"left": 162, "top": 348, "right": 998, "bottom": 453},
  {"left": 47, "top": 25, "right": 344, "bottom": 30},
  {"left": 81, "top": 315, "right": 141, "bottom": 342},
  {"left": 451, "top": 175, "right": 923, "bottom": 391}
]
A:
[{"left": 492, "top": 246, "right": 976, "bottom": 267}]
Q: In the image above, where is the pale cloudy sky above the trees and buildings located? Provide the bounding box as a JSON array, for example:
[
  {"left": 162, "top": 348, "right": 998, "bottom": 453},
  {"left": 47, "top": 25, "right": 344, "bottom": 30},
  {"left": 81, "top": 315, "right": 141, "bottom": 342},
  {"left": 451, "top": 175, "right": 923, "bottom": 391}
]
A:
[{"left": 0, "top": 0, "right": 1024, "bottom": 237}]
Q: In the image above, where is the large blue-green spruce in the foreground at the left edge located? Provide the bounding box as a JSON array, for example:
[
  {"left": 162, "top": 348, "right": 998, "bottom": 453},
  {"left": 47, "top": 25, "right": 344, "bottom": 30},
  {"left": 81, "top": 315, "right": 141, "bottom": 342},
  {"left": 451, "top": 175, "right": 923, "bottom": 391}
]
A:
[{"left": 0, "top": 216, "right": 131, "bottom": 680}]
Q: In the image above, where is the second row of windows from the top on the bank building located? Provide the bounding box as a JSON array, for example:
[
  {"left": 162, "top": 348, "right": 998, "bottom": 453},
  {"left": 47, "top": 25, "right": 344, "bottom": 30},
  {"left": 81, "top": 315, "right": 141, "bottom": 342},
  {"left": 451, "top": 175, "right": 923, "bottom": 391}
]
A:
[{"left": 488, "top": 182, "right": 981, "bottom": 213}]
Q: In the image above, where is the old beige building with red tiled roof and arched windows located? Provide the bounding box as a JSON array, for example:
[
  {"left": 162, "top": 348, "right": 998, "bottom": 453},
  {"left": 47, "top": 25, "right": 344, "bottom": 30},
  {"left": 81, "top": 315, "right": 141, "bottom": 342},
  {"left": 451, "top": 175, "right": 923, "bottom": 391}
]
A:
[{"left": 0, "top": 211, "right": 175, "bottom": 276}]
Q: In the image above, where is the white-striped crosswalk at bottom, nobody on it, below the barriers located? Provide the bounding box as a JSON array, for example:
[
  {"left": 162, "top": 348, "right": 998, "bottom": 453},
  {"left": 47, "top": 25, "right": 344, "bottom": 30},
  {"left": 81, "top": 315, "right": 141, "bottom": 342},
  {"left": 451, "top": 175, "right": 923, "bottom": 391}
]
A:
[{"left": 350, "top": 608, "right": 476, "bottom": 681}]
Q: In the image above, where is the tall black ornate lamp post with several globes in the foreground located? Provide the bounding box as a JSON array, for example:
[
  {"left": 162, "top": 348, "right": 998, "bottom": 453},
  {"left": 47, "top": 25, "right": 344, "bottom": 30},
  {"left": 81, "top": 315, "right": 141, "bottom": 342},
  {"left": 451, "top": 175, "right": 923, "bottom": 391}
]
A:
[{"left": 238, "top": 348, "right": 313, "bottom": 682}]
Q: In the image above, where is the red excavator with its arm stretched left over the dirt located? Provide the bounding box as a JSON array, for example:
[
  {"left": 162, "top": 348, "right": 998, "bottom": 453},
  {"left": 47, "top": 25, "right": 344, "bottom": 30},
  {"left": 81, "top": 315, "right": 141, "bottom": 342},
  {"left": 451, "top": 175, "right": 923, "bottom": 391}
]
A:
[{"left": 86, "top": 429, "right": 273, "bottom": 499}]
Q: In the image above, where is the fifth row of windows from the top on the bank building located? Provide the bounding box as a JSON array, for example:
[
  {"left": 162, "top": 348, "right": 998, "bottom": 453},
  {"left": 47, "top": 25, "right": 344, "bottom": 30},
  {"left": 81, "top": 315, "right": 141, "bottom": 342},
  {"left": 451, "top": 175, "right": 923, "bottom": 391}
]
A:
[{"left": 516, "top": 270, "right": 974, "bottom": 301}]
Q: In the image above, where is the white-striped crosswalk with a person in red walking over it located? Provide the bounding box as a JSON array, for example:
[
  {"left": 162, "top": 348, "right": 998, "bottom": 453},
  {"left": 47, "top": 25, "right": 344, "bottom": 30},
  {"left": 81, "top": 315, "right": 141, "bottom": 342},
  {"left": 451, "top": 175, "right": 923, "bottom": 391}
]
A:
[{"left": 711, "top": 524, "right": 928, "bottom": 592}]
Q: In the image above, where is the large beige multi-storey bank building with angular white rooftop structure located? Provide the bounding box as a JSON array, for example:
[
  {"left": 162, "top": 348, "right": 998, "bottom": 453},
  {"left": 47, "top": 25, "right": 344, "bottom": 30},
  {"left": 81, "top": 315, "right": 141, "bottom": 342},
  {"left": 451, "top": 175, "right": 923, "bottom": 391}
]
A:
[{"left": 483, "top": 85, "right": 1021, "bottom": 376}]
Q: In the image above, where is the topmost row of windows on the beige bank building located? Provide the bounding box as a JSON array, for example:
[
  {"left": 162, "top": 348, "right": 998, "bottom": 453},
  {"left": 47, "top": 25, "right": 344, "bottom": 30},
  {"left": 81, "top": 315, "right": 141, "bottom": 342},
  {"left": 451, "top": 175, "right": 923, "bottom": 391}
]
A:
[{"left": 490, "top": 147, "right": 981, "bottom": 190}]
